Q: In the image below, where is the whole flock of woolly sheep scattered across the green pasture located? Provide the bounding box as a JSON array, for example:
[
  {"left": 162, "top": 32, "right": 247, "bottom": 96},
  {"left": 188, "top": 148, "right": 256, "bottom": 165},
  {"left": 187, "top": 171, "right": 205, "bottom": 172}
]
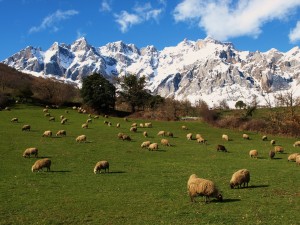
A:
[{"left": 11, "top": 107, "right": 300, "bottom": 202}]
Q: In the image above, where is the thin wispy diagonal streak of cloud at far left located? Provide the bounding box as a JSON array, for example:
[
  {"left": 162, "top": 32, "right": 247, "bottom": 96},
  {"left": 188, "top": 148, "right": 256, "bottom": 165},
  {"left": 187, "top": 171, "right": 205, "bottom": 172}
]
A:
[{"left": 28, "top": 10, "right": 79, "bottom": 34}]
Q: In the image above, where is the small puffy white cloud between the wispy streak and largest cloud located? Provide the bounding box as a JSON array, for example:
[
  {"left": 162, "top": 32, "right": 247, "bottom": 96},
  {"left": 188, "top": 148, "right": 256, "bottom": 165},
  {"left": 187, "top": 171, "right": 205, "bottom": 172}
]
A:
[{"left": 115, "top": 3, "right": 163, "bottom": 33}]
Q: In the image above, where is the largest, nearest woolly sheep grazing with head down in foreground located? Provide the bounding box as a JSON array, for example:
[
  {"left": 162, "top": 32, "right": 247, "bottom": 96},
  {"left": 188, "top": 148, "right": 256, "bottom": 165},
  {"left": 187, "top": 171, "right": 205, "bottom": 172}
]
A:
[{"left": 187, "top": 174, "right": 223, "bottom": 203}]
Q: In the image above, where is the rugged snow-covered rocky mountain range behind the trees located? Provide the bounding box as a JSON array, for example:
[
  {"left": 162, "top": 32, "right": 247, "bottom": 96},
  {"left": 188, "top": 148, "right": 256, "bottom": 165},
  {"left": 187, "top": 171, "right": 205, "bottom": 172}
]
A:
[{"left": 2, "top": 38, "right": 300, "bottom": 107}]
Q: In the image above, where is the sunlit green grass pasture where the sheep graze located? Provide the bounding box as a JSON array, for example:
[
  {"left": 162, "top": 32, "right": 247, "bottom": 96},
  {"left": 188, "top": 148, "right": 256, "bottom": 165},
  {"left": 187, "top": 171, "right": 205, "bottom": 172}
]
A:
[{"left": 0, "top": 105, "right": 300, "bottom": 224}]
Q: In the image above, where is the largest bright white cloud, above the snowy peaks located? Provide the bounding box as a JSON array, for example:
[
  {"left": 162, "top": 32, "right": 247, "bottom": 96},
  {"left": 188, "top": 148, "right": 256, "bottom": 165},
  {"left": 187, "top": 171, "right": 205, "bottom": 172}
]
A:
[{"left": 173, "top": 0, "right": 300, "bottom": 41}]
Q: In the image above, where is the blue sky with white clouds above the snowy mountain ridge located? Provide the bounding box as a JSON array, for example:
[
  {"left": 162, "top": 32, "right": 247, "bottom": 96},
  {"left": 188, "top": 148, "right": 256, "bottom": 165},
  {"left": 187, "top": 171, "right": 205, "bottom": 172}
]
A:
[{"left": 0, "top": 0, "right": 300, "bottom": 60}]
